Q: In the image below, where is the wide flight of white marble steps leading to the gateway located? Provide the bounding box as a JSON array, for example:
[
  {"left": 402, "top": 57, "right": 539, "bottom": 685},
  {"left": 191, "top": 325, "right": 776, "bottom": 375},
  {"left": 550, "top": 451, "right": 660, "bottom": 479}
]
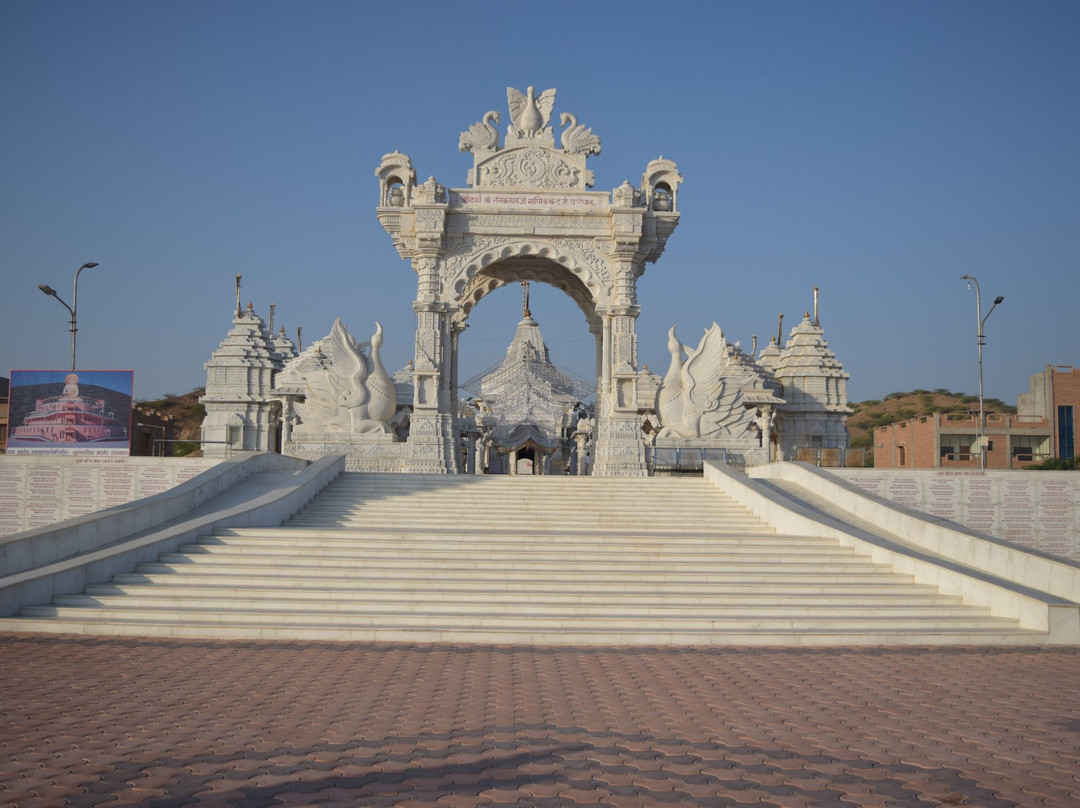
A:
[{"left": 2, "top": 473, "right": 1041, "bottom": 645}]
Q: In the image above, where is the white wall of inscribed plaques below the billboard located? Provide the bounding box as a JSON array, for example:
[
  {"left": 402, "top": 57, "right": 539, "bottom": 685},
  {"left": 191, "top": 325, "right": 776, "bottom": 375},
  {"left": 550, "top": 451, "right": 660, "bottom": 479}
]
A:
[{"left": 0, "top": 455, "right": 217, "bottom": 536}]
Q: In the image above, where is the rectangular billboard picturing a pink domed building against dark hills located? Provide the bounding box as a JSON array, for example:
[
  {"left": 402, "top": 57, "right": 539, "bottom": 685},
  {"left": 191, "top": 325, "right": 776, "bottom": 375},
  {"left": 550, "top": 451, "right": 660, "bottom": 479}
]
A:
[{"left": 8, "top": 371, "right": 135, "bottom": 457}]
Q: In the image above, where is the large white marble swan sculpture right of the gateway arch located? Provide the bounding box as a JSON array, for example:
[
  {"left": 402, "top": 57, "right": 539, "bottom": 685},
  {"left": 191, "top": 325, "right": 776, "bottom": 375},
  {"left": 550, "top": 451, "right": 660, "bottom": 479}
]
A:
[{"left": 657, "top": 323, "right": 752, "bottom": 437}]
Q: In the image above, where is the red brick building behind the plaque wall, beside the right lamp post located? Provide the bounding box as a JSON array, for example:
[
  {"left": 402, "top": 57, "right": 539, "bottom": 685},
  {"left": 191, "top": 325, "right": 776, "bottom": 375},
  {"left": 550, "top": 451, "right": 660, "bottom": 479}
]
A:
[{"left": 874, "top": 365, "right": 1080, "bottom": 469}]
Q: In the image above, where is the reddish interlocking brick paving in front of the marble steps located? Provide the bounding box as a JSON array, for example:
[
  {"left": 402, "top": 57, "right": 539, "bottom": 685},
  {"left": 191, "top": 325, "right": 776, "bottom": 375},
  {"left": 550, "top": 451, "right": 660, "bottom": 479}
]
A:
[{"left": 0, "top": 634, "right": 1080, "bottom": 808}]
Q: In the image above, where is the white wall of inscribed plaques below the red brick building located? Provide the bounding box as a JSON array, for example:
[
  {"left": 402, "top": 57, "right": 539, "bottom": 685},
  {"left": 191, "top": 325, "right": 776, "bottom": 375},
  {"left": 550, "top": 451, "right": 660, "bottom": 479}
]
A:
[{"left": 828, "top": 469, "right": 1080, "bottom": 560}]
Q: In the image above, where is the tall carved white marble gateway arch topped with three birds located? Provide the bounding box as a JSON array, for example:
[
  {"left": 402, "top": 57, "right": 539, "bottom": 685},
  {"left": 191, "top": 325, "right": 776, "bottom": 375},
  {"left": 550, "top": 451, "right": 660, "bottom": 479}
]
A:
[{"left": 376, "top": 87, "right": 683, "bottom": 476}]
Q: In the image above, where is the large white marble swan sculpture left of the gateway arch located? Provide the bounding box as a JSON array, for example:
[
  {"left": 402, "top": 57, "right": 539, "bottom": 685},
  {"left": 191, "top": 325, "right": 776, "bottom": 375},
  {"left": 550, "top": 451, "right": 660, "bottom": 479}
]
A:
[{"left": 296, "top": 319, "right": 397, "bottom": 435}]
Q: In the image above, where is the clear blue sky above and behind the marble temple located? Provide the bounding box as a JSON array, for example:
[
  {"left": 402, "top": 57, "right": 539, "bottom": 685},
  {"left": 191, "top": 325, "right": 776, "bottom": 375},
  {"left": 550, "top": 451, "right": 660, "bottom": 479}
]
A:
[{"left": 0, "top": 0, "right": 1080, "bottom": 403}]
